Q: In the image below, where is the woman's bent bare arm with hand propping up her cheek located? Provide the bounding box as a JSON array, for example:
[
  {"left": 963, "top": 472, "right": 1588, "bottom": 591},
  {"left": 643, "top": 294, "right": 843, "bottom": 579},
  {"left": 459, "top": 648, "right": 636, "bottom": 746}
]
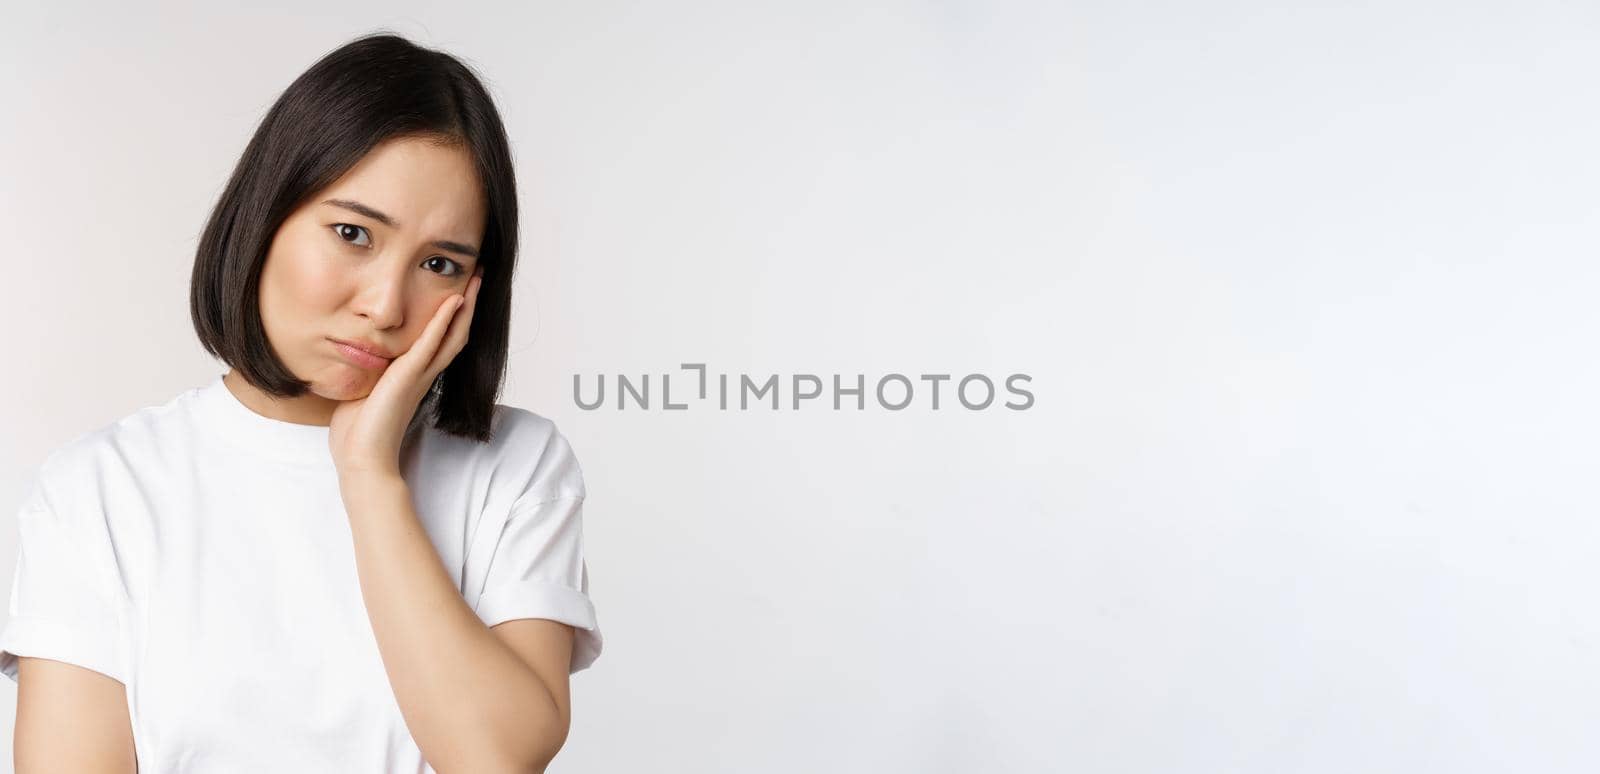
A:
[{"left": 328, "top": 265, "right": 573, "bottom": 774}]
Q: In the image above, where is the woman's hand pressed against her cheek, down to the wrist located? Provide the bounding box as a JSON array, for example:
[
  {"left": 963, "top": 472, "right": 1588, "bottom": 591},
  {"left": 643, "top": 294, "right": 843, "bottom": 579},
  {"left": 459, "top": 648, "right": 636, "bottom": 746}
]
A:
[{"left": 328, "top": 267, "right": 483, "bottom": 480}]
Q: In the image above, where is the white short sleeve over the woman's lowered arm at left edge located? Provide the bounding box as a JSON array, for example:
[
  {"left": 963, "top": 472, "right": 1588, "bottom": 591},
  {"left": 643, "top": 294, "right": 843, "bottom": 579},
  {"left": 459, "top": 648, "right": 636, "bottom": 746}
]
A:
[{"left": 0, "top": 483, "right": 128, "bottom": 684}]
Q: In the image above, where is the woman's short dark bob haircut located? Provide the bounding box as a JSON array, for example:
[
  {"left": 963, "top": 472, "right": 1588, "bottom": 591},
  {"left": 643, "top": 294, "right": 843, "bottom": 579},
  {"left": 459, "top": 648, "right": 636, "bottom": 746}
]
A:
[{"left": 189, "top": 32, "right": 517, "bottom": 441}]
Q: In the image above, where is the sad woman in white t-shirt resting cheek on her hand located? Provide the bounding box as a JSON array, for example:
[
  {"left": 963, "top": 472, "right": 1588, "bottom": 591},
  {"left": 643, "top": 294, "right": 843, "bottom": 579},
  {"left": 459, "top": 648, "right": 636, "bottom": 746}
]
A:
[{"left": 0, "top": 34, "right": 602, "bottom": 774}]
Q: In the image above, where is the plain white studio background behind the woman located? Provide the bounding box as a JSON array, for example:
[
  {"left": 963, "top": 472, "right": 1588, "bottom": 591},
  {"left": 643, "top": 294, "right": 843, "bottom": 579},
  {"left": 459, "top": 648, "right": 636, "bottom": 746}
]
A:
[{"left": 0, "top": 2, "right": 1600, "bottom": 774}]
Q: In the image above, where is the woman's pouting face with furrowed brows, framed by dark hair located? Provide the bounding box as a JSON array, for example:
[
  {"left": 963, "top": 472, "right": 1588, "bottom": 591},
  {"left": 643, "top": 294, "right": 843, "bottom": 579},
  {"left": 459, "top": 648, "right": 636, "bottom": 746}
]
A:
[{"left": 261, "top": 138, "right": 486, "bottom": 401}]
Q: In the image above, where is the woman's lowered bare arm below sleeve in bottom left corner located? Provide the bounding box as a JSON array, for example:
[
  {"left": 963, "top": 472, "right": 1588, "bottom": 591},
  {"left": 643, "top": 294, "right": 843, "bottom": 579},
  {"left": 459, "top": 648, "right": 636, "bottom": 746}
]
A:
[{"left": 11, "top": 656, "right": 139, "bottom": 774}]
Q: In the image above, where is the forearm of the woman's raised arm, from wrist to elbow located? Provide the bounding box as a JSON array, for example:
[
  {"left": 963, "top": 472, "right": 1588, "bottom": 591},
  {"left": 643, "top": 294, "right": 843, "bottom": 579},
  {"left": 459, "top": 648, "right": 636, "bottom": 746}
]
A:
[{"left": 341, "top": 475, "right": 562, "bottom": 774}]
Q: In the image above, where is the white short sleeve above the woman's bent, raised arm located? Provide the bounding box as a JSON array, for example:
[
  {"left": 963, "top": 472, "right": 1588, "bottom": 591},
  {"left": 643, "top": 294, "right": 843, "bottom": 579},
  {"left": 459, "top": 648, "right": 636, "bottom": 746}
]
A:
[{"left": 474, "top": 429, "right": 603, "bottom": 673}]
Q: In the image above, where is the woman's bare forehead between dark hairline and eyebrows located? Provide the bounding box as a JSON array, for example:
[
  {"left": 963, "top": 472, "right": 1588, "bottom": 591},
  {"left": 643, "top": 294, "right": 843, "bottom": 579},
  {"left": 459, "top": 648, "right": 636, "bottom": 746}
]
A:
[{"left": 314, "top": 138, "right": 486, "bottom": 243}]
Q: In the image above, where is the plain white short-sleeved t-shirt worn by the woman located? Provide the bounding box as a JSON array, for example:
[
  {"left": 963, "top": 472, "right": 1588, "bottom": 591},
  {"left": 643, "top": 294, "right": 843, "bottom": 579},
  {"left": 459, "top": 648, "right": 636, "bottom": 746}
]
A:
[{"left": 0, "top": 374, "right": 602, "bottom": 774}]
